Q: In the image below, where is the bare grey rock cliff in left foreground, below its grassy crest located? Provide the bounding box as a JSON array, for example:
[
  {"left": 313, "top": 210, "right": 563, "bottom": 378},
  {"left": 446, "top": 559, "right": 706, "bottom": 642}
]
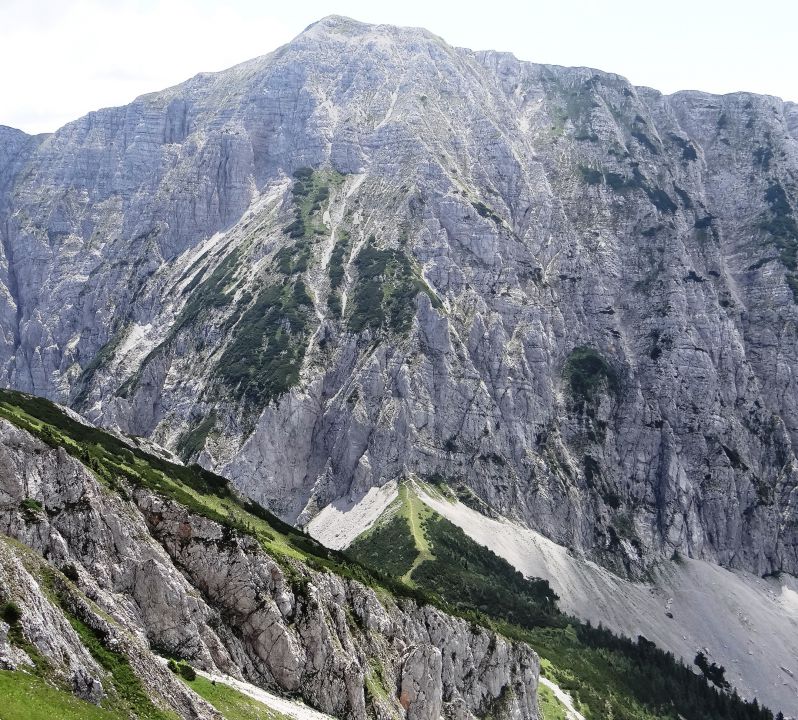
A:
[{"left": 0, "top": 420, "right": 538, "bottom": 720}]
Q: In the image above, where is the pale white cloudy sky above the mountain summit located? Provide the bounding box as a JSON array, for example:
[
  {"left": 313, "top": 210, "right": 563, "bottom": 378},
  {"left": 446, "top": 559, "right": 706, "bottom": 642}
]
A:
[{"left": 0, "top": 0, "right": 798, "bottom": 133}]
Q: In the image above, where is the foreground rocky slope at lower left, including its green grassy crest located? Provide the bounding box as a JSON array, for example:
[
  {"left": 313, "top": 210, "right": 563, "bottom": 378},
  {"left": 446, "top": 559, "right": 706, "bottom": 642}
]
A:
[{"left": 0, "top": 391, "right": 538, "bottom": 720}]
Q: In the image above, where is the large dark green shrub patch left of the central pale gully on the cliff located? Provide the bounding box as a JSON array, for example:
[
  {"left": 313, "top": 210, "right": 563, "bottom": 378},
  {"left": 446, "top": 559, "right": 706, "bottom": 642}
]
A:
[{"left": 215, "top": 280, "right": 313, "bottom": 408}]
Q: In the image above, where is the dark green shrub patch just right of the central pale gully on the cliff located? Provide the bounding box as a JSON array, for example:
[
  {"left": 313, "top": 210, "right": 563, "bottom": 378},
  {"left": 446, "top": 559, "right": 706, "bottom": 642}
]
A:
[{"left": 348, "top": 235, "right": 442, "bottom": 334}]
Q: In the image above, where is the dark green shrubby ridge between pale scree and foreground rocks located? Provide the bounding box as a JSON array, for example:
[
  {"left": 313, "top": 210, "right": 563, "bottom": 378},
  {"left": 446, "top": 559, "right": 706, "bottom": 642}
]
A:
[{"left": 348, "top": 486, "right": 773, "bottom": 720}]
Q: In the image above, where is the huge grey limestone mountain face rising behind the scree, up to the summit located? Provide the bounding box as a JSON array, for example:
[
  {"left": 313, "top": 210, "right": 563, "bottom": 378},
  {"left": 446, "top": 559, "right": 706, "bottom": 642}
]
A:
[{"left": 0, "top": 17, "right": 798, "bottom": 574}]
